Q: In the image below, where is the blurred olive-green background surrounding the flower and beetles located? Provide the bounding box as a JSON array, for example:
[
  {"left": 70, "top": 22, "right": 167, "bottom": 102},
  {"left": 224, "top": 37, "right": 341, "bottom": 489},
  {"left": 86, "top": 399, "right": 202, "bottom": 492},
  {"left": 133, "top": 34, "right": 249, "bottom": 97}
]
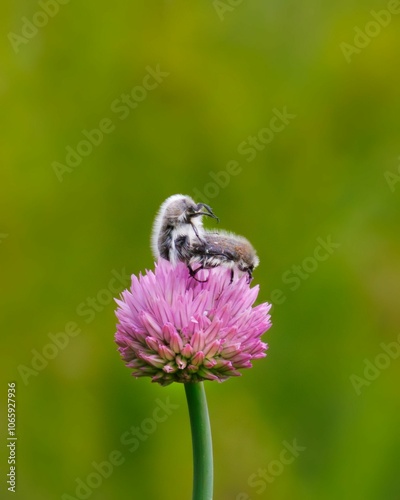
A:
[{"left": 0, "top": 0, "right": 400, "bottom": 500}]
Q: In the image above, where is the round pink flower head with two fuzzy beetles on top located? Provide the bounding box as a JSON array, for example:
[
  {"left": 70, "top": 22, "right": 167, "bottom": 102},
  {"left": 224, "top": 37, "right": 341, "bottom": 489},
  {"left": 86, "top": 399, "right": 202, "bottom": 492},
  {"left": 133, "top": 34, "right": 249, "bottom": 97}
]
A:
[{"left": 115, "top": 259, "right": 271, "bottom": 385}]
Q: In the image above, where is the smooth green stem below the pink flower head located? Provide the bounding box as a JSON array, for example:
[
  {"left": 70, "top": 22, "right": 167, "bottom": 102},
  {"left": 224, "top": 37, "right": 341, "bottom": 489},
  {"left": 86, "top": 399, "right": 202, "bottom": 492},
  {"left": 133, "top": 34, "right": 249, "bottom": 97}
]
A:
[{"left": 184, "top": 382, "right": 213, "bottom": 500}]
